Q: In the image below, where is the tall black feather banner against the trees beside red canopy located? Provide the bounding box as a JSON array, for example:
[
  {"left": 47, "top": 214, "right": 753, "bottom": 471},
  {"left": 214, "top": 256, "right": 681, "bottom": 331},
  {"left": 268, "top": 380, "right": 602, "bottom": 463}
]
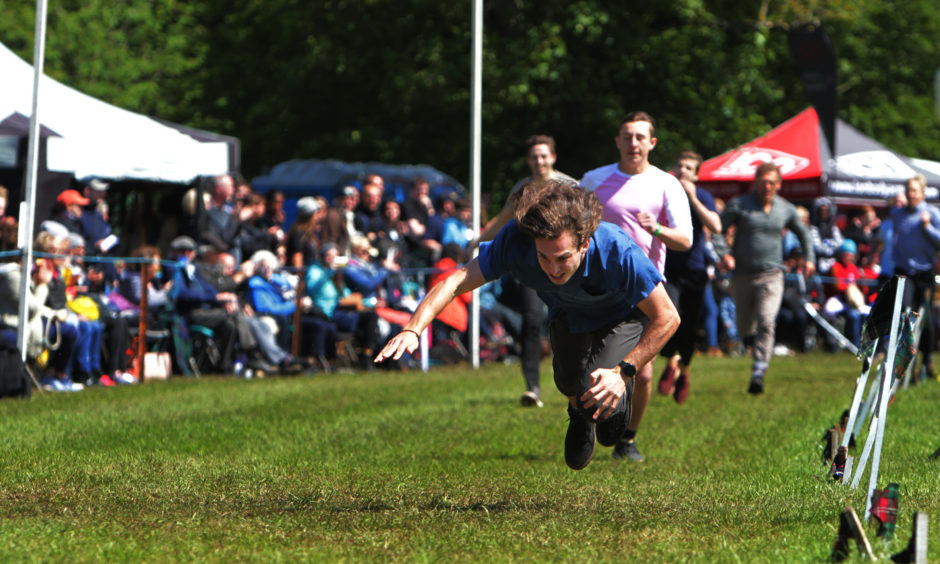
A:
[{"left": 790, "top": 24, "right": 839, "bottom": 158}]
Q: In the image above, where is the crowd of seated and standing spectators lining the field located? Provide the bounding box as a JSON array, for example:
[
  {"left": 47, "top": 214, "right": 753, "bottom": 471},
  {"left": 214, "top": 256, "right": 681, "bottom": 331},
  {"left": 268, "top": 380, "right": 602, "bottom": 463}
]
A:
[{"left": 0, "top": 170, "right": 936, "bottom": 391}]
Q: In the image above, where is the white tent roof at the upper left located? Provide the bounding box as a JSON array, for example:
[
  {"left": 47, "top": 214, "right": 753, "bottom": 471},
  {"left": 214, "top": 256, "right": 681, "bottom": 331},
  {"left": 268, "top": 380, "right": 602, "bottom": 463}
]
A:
[{"left": 0, "top": 43, "right": 230, "bottom": 183}]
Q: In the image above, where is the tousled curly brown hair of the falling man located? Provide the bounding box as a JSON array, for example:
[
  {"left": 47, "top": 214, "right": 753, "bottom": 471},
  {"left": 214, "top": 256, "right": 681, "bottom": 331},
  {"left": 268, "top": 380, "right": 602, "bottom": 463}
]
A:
[{"left": 512, "top": 180, "right": 603, "bottom": 247}]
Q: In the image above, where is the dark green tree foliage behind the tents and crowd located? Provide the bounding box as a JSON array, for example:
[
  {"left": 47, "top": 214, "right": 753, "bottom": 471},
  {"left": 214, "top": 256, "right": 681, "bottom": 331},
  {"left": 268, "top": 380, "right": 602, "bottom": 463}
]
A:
[{"left": 0, "top": 0, "right": 940, "bottom": 215}]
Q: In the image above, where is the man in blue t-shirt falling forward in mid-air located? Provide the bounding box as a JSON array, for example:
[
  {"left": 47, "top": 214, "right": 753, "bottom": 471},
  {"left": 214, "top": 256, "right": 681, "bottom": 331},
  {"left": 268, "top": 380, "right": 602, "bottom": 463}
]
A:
[{"left": 375, "top": 180, "right": 679, "bottom": 470}]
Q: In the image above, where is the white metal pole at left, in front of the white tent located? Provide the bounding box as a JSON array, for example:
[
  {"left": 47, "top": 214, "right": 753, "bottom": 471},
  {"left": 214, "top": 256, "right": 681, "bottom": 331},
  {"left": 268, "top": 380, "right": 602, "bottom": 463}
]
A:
[{"left": 16, "top": 0, "right": 46, "bottom": 362}]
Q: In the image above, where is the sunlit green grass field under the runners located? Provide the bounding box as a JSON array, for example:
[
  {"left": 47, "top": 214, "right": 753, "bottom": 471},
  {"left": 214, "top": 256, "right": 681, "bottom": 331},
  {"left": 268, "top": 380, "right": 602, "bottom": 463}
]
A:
[{"left": 0, "top": 354, "right": 940, "bottom": 562}]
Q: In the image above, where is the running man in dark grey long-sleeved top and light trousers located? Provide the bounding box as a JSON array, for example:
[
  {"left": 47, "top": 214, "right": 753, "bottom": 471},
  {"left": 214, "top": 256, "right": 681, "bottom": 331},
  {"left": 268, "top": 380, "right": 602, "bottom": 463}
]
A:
[{"left": 715, "top": 162, "right": 816, "bottom": 394}]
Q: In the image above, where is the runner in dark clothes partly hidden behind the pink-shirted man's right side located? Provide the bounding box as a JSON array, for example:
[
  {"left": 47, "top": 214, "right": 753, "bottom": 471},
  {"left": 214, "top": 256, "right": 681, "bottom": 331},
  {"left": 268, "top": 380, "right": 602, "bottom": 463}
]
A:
[{"left": 659, "top": 151, "right": 721, "bottom": 403}]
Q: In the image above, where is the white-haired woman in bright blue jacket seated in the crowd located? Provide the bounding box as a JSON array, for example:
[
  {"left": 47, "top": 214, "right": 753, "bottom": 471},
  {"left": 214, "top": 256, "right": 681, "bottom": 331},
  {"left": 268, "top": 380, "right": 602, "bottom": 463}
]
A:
[{"left": 248, "top": 251, "right": 336, "bottom": 367}]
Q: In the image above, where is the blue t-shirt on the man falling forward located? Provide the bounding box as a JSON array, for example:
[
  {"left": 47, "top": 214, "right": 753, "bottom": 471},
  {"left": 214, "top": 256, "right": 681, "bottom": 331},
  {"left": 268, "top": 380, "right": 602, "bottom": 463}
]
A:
[{"left": 477, "top": 220, "right": 663, "bottom": 333}]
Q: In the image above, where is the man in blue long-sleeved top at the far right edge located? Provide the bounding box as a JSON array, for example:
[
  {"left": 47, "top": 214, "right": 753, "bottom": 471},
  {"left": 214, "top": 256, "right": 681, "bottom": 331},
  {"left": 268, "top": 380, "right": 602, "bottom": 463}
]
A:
[{"left": 891, "top": 174, "right": 940, "bottom": 378}]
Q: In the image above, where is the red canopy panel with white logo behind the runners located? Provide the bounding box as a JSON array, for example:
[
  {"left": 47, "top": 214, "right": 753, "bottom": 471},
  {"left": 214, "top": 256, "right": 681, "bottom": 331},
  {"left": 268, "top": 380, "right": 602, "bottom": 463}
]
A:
[{"left": 699, "top": 108, "right": 829, "bottom": 200}]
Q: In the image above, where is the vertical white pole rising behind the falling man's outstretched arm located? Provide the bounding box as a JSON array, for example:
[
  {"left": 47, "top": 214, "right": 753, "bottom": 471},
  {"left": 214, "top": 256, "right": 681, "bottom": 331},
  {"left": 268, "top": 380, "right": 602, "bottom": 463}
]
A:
[{"left": 470, "top": 0, "right": 483, "bottom": 368}]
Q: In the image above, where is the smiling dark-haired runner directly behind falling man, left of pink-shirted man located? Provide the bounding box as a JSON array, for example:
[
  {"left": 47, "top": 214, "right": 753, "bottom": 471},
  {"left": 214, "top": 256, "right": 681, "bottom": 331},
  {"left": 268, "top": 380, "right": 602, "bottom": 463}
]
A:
[{"left": 480, "top": 135, "right": 577, "bottom": 407}]
